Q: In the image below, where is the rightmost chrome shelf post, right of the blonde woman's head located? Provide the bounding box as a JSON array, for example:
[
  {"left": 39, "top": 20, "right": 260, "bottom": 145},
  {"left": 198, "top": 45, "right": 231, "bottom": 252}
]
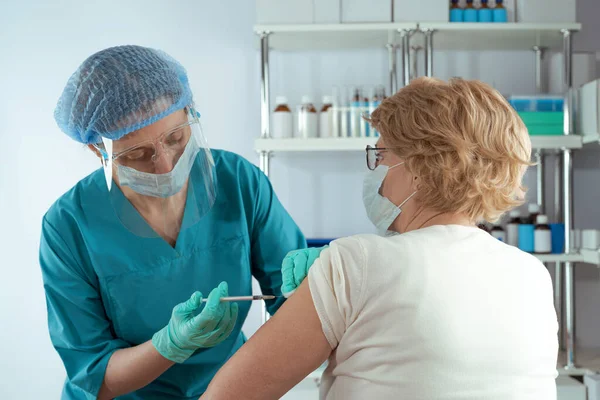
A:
[{"left": 561, "top": 29, "right": 576, "bottom": 369}]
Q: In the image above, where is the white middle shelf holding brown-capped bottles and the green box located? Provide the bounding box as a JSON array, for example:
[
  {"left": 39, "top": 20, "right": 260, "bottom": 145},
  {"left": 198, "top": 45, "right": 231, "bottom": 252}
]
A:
[{"left": 254, "top": 135, "right": 582, "bottom": 152}]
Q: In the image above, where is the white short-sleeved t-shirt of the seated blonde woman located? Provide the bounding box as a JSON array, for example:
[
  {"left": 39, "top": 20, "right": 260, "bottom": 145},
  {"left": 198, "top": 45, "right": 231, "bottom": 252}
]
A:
[{"left": 308, "top": 225, "right": 558, "bottom": 400}]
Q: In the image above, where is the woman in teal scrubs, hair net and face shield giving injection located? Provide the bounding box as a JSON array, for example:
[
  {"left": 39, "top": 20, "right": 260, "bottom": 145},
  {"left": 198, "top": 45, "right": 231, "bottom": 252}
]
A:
[{"left": 40, "top": 46, "right": 306, "bottom": 399}]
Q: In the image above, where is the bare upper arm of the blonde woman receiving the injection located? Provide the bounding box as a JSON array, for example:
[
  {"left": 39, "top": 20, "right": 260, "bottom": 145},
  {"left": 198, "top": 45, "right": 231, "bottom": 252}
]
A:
[{"left": 202, "top": 282, "right": 332, "bottom": 400}]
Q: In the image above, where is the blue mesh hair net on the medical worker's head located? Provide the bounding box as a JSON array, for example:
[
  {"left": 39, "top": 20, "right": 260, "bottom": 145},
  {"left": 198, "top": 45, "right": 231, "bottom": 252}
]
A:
[{"left": 54, "top": 46, "right": 192, "bottom": 144}]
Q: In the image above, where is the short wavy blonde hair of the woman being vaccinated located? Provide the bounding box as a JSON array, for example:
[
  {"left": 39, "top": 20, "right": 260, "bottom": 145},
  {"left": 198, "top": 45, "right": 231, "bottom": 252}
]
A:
[{"left": 368, "top": 78, "right": 533, "bottom": 222}]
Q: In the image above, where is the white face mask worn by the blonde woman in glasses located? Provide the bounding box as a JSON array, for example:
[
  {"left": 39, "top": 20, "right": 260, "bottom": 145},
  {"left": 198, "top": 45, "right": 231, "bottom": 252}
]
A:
[{"left": 363, "top": 163, "right": 417, "bottom": 236}]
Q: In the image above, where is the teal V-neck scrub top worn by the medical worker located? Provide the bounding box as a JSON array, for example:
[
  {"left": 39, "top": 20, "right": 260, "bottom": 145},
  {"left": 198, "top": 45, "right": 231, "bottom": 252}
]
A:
[{"left": 40, "top": 150, "right": 306, "bottom": 400}]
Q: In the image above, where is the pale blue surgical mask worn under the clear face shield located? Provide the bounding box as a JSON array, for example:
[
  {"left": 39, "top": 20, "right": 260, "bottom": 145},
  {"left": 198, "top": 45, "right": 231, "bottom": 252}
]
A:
[{"left": 117, "top": 137, "right": 200, "bottom": 198}]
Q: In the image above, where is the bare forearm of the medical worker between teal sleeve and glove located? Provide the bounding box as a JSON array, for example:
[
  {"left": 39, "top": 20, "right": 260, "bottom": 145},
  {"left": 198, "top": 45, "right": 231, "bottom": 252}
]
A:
[{"left": 98, "top": 340, "right": 175, "bottom": 400}]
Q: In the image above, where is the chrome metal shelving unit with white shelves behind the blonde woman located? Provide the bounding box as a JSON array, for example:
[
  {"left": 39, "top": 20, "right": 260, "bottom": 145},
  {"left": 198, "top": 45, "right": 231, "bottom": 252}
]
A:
[{"left": 254, "top": 22, "right": 600, "bottom": 375}]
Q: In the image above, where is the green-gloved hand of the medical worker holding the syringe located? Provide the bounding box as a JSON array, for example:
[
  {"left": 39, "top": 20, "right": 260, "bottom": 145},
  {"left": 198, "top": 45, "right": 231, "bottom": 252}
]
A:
[{"left": 152, "top": 282, "right": 238, "bottom": 363}]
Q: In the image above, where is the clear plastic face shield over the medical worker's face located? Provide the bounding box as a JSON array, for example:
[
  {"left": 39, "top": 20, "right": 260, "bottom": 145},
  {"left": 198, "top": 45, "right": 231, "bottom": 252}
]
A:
[{"left": 95, "top": 106, "right": 216, "bottom": 242}]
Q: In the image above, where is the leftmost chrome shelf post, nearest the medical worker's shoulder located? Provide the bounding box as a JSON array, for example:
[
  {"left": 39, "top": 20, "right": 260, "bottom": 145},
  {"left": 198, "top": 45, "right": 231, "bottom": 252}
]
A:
[{"left": 259, "top": 32, "right": 271, "bottom": 324}]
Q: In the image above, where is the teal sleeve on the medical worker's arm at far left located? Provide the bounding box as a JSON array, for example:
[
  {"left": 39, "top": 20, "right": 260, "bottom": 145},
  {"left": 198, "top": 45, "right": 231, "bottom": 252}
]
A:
[{"left": 40, "top": 219, "right": 128, "bottom": 396}]
